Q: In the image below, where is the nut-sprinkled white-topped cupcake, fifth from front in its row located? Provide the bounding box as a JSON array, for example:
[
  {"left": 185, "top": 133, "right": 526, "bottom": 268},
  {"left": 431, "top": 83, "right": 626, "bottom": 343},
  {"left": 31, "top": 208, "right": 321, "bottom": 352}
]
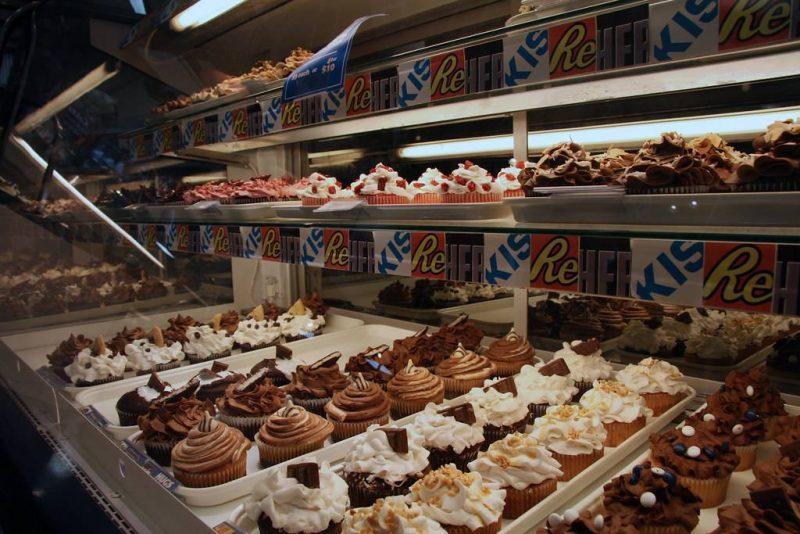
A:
[{"left": 580, "top": 380, "right": 653, "bottom": 447}]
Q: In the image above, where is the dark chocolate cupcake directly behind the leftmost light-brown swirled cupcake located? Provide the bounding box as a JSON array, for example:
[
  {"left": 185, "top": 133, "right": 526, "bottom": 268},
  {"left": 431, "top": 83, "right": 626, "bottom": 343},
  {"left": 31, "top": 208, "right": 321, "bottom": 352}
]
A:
[{"left": 139, "top": 380, "right": 216, "bottom": 465}]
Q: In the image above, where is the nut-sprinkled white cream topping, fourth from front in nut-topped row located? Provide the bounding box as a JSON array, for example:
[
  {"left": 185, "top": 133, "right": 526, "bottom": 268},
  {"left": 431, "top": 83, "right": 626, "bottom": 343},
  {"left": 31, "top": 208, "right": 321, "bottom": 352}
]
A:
[{"left": 531, "top": 405, "right": 606, "bottom": 456}]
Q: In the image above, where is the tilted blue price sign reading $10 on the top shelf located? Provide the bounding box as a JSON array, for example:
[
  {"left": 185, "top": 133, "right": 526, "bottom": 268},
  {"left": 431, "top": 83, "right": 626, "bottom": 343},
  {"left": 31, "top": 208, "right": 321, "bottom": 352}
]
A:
[{"left": 283, "top": 14, "right": 385, "bottom": 102}]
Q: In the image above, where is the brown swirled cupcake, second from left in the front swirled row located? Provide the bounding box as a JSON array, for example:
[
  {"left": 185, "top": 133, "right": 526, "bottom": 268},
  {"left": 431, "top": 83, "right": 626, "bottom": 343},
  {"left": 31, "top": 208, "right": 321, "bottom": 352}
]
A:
[{"left": 255, "top": 397, "right": 333, "bottom": 467}]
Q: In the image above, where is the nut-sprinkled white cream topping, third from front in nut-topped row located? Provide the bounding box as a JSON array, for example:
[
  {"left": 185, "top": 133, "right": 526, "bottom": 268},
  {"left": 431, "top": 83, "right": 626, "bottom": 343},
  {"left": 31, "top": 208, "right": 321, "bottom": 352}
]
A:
[{"left": 469, "top": 433, "right": 563, "bottom": 490}]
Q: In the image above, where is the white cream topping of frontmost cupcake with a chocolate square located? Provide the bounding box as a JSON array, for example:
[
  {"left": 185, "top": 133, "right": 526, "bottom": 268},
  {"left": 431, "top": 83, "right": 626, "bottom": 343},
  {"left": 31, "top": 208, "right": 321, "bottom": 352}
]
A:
[{"left": 244, "top": 458, "right": 350, "bottom": 533}]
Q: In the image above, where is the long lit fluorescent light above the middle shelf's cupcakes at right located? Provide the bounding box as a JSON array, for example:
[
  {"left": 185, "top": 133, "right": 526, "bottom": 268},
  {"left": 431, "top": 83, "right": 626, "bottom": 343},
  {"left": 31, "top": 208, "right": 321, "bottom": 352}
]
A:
[{"left": 398, "top": 107, "right": 800, "bottom": 159}]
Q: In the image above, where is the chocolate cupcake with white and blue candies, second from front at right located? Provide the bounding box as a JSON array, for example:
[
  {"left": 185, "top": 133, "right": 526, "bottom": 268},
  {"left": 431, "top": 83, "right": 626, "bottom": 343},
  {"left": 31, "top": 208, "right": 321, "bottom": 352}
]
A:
[{"left": 603, "top": 462, "right": 700, "bottom": 533}]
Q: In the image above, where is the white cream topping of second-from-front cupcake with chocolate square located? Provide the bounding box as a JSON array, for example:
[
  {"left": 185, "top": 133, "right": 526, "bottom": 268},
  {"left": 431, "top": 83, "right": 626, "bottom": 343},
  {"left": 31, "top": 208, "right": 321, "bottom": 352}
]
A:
[{"left": 344, "top": 425, "right": 430, "bottom": 484}]
